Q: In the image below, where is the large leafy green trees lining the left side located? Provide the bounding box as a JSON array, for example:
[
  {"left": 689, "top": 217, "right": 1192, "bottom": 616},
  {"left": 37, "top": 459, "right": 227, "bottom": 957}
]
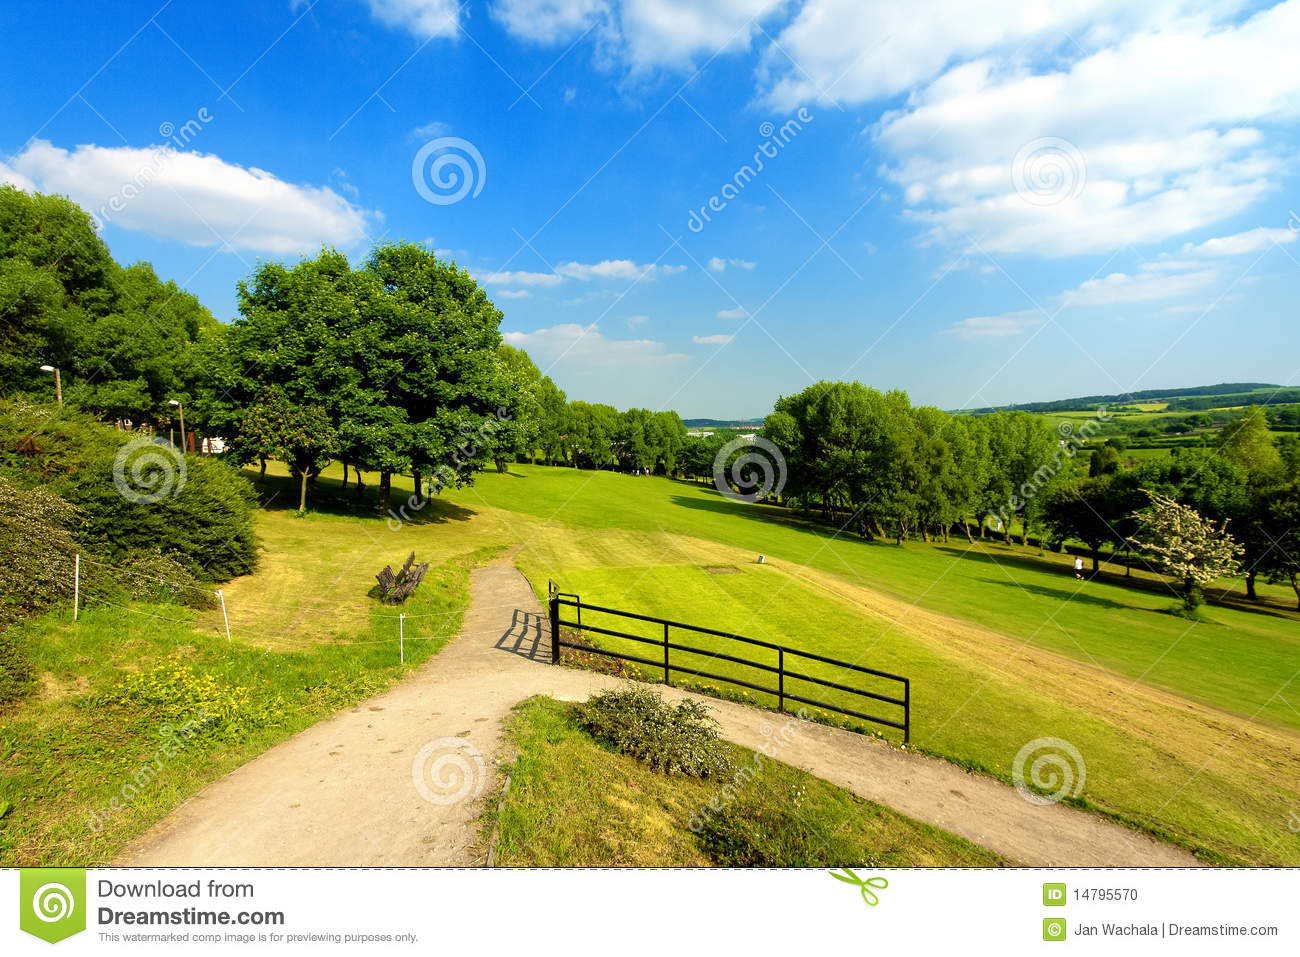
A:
[{"left": 0, "top": 187, "right": 685, "bottom": 510}]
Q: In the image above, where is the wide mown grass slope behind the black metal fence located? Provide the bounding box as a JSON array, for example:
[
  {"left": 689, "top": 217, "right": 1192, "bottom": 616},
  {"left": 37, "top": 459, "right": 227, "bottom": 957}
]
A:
[{"left": 444, "top": 467, "right": 1300, "bottom": 863}]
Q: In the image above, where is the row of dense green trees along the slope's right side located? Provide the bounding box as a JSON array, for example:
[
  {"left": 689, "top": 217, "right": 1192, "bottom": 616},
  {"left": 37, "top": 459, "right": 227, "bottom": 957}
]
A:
[{"left": 712, "top": 382, "right": 1300, "bottom": 599}]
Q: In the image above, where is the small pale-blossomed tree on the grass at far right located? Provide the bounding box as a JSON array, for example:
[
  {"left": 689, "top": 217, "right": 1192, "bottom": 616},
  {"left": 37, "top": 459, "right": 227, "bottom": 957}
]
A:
[{"left": 1132, "top": 493, "right": 1243, "bottom": 611}]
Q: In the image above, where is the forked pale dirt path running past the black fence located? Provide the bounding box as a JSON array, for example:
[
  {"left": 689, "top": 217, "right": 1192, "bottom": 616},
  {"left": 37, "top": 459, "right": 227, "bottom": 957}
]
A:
[{"left": 122, "top": 559, "right": 1197, "bottom": 866}]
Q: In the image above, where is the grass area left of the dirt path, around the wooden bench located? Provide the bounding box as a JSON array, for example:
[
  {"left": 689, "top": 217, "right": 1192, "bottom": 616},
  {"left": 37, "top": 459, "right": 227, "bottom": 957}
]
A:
[{"left": 0, "top": 470, "right": 502, "bottom": 866}]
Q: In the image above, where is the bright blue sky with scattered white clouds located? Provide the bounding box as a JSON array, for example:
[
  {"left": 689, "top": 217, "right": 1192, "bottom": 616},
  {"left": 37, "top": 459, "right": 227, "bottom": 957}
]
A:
[{"left": 0, "top": 0, "right": 1300, "bottom": 417}]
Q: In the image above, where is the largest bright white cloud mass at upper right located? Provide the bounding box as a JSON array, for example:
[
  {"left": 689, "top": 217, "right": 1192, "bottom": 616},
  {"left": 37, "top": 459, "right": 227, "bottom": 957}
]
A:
[{"left": 857, "top": 0, "right": 1300, "bottom": 256}]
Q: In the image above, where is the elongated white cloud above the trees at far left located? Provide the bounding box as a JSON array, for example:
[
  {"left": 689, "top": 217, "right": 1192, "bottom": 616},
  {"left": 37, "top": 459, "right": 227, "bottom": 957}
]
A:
[{"left": 12, "top": 139, "right": 374, "bottom": 255}]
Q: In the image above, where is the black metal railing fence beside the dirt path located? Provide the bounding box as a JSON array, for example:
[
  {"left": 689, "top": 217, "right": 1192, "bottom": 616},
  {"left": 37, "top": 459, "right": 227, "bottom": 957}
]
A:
[{"left": 547, "top": 581, "right": 911, "bottom": 744}]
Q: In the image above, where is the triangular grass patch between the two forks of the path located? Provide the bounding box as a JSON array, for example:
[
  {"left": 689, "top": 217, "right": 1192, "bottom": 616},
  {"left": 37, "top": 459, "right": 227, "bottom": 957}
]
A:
[{"left": 484, "top": 698, "right": 1006, "bottom": 867}]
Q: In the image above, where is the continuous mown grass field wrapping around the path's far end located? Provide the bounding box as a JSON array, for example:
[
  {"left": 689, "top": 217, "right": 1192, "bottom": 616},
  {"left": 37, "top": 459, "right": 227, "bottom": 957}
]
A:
[{"left": 0, "top": 464, "right": 1300, "bottom": 865}]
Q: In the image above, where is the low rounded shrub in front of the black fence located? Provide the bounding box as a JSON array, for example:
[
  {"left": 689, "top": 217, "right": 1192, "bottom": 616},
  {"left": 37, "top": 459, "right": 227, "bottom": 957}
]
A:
[{"left": 579, "top": 688, "right": 732, "bottom": 778}]
